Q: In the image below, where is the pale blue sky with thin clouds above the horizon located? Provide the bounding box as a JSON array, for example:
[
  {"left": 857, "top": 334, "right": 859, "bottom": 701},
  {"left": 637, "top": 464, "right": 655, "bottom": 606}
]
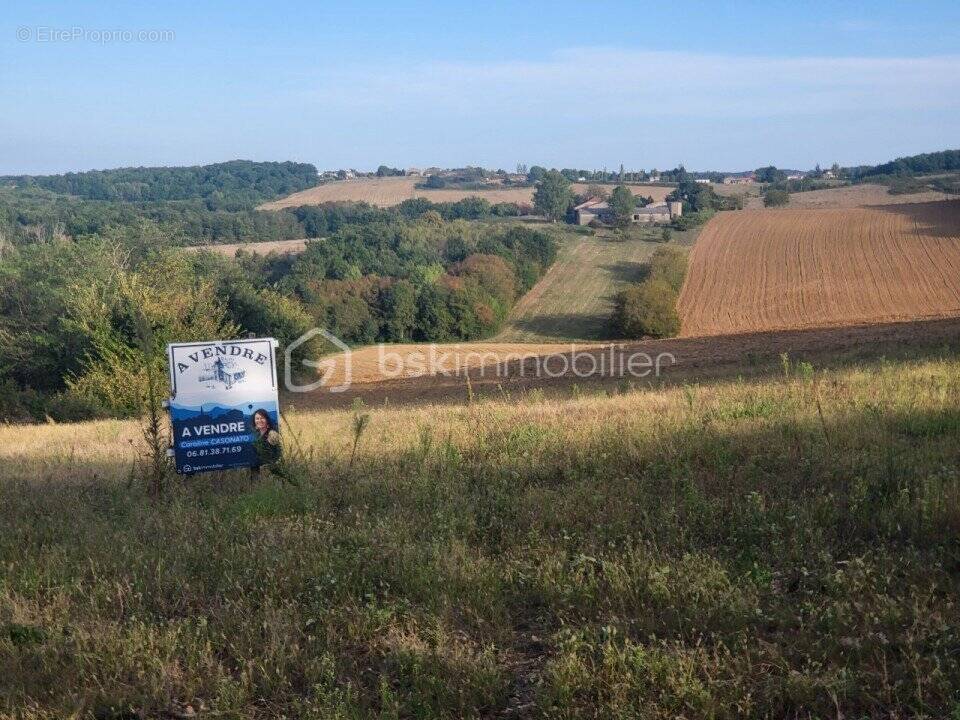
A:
[{"left": 0, "top": 0, "right": 960, "bottom": 174}]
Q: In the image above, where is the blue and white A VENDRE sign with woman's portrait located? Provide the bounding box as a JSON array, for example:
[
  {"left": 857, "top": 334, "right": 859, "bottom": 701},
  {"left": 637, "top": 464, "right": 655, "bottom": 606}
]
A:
[{"left": 167, "top": 338, "right": 280, "bottom": 473}]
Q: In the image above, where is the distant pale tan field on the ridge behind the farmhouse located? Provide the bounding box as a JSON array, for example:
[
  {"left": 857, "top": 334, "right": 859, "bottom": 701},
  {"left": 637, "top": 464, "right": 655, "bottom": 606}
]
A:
[{"left": 260, "top": 177, "right": 673, "bottom": 210}]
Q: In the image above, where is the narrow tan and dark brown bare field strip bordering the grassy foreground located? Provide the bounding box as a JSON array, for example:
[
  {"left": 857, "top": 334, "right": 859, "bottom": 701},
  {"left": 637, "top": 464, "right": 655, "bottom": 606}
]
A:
[{"left": 284, "top": 318, "right": 960, "bottom": 409}]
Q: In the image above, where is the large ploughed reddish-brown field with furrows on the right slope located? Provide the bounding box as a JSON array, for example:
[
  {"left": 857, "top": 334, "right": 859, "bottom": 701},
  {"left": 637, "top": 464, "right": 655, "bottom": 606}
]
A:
[{"left": 680, "top": 201, "right": 960, "bottom": 337}]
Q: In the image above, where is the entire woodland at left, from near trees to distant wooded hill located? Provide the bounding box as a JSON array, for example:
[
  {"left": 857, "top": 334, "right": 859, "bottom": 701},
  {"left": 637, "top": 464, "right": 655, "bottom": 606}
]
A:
[{"left": 0, "top": 163, "right": 556, "bottom": 419}]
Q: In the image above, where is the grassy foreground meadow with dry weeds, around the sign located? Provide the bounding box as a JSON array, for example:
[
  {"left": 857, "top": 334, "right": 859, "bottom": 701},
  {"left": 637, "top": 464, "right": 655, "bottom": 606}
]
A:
[{"left": 0, "top": 356, "right": 960, "bottom": 720}]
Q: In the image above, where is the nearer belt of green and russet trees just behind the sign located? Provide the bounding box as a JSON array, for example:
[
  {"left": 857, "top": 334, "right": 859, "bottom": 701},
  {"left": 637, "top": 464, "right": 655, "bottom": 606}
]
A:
[{"left": 0, "top": 210, "right": 556, "bottom": 420}]
